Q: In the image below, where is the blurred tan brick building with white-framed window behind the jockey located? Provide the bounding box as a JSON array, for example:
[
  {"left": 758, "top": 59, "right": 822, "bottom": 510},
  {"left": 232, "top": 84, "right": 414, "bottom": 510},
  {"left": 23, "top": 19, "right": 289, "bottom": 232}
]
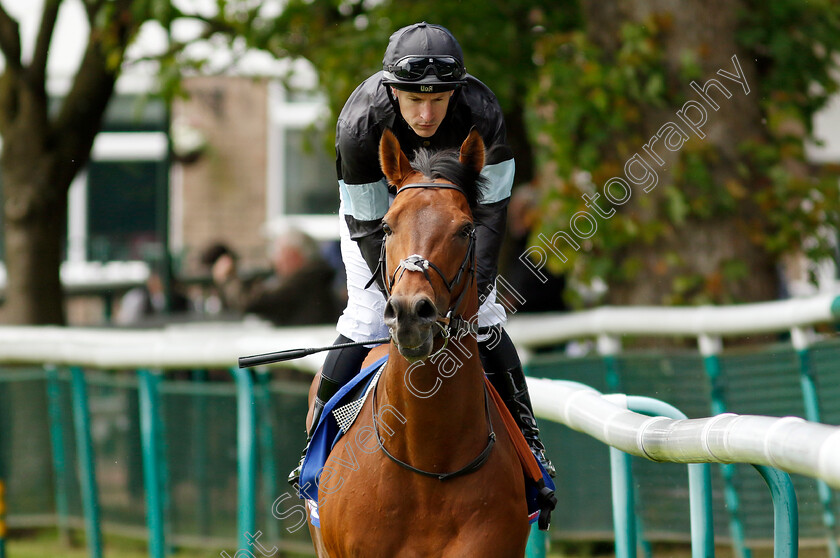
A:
[{"left": 169, "top": 73, "right": 338, "bottom": 278}]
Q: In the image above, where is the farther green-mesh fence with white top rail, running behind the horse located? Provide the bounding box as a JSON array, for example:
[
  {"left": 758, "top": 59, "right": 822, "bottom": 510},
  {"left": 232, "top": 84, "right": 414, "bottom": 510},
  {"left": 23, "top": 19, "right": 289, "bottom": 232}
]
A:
[{"left": 0, "top": 300, "right": 840, "bottom": 558}]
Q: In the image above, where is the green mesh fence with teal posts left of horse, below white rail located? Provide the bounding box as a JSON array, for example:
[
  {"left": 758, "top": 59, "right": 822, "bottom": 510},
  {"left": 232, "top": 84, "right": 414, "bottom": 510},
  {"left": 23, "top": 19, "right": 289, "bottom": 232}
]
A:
[{"left": 0, "top": 366, "right": 316, "bottom": 557}]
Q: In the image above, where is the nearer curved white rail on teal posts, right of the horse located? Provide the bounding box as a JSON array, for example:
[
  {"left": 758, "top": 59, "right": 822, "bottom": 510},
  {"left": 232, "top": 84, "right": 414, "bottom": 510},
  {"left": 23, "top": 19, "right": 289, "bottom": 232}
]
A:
[{"left": 531, "top": 380, "right": 840, "bottom": 558}]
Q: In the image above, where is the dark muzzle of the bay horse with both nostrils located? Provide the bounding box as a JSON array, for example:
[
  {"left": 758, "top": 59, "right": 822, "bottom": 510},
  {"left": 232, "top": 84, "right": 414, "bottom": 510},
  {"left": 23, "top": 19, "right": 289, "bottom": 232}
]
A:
[{"left": 385, "top": 294, "right": 438, "bottom": 362}]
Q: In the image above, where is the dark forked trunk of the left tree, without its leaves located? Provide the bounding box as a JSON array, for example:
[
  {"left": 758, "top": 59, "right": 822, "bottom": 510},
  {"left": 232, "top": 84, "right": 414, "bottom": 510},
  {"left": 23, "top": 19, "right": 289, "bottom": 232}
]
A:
[{"left": 0, "top": 15, "right": 124, "bottom": 325}]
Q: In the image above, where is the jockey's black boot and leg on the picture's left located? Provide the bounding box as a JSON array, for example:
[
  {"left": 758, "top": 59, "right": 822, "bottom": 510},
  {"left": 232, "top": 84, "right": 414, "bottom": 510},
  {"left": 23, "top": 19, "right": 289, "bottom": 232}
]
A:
[{"left": 287, "top": 335, "right": 370, "bottom": 487}]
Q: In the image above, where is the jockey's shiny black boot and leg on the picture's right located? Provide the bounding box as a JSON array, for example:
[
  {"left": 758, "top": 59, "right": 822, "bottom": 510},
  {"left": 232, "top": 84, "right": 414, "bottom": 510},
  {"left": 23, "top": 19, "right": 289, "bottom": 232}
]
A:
[{"left": 478, "top": 329, "right": 556, "bottom": 478}]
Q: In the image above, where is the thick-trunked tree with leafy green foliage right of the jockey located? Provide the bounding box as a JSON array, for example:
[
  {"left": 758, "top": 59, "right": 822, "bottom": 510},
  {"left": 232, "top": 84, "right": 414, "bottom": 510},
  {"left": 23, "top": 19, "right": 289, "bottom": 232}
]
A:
[{"left": 530, "top": 0, "right": 840, "bottom": 304}]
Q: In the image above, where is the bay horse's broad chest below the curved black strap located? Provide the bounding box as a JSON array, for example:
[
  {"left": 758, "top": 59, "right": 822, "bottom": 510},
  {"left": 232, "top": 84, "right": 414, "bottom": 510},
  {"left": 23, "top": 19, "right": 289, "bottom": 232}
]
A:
[{"left": 319, "top": 402, "right": 529, "bottom": 558}]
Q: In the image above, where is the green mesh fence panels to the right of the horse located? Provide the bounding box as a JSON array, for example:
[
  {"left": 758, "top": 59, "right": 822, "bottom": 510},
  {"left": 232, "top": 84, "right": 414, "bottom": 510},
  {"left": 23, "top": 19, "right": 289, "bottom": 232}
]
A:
[{"left": 528, "top": 344, "right": 840, "bottom": 556}]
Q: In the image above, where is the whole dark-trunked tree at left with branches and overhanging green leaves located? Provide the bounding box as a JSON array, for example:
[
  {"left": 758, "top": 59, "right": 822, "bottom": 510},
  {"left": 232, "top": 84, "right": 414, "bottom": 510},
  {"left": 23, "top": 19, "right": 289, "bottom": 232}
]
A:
[{"left": 0, "top": 0, "right": 282, "bottom": 324}]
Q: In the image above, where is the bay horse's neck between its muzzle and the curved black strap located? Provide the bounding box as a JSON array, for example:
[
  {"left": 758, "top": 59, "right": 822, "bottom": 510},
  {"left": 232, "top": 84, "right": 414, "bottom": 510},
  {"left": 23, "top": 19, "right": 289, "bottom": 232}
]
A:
[{"left": 380, "top": 336, "right": 488, "bottom": 462}]
